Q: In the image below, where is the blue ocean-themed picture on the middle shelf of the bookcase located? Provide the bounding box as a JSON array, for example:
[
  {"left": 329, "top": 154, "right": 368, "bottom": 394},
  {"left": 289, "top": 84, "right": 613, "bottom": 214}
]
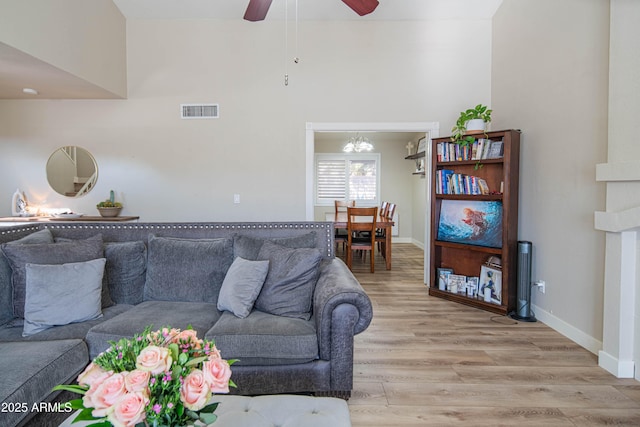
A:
[{"left": 437, "top": 199, "right": 502, "bottom": 248}]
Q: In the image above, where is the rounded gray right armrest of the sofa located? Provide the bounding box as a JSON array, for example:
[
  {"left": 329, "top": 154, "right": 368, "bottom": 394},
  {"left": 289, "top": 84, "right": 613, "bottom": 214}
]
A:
[{"left": 313, "top": 258, "right": 373, "bottom": 360}]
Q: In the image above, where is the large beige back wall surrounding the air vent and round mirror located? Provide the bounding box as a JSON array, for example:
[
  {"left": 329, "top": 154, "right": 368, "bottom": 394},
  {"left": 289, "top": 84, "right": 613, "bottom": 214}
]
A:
[{"left": 0, "top": 20, "right": 491, "bottom": 221}]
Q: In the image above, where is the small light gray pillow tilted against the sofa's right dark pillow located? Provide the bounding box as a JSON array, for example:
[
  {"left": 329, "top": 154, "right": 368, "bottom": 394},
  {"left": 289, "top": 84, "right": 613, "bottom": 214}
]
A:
[{"left": 218, "top": 257, "right": 269, "bottom": 319}]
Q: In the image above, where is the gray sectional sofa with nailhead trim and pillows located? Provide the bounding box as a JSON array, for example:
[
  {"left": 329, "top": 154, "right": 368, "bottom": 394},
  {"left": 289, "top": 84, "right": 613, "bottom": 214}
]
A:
[{"left": 0, "top": 222, "right": 372, "bottom": 426}]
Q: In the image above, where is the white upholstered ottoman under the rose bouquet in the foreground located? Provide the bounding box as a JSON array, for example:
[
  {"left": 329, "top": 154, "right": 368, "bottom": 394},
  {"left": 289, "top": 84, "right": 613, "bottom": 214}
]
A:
[{"left": 60, "top": 394, "right": 351, "bottom": 427}]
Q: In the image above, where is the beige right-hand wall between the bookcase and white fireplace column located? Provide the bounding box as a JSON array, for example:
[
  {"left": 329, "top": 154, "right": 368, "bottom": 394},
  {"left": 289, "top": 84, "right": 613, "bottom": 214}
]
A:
[{"left": 491, "top": 0, "right": 609, "bottom": 352}]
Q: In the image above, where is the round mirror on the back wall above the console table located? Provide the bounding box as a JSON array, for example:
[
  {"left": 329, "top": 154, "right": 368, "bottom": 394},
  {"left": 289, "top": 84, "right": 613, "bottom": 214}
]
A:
[{"left": 47, "top": 145, "right": 98, "bottom": 197}]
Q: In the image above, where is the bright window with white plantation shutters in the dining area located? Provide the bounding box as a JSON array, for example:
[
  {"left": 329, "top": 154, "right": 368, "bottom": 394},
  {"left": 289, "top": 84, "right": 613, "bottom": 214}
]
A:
[{"left": 315, "top": 153, "right": 380, "bottom": 206}]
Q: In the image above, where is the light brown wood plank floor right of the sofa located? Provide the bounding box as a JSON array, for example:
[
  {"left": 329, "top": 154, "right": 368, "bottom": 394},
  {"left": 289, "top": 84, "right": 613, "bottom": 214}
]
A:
[{"left": 342, "top": 244, "right": 640, "bottom": 427}]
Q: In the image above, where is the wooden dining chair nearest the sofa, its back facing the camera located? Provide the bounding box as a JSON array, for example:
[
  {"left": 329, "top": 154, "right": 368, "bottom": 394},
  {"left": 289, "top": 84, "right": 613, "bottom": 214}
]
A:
[{"left": 347, "top": 206, "right": 378, "bottom": 273}]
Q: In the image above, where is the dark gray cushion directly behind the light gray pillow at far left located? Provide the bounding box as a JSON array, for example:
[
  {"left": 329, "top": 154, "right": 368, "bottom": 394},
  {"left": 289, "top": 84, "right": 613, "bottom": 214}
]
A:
[{"left": 2, "top": 234, "right": 103, "bottom": 317}]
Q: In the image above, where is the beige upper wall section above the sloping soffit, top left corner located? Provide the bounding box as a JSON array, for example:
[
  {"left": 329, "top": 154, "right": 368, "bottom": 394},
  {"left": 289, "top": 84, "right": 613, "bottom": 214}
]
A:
[{"left": 0, "top": 0, "right": 127, "bottom": 97}]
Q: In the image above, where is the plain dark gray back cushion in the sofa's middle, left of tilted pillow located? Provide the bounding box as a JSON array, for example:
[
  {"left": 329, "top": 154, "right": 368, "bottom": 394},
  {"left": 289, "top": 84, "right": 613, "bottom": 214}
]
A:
[{"left": 144, "top": 235, "right": 233, "bottom": 304}]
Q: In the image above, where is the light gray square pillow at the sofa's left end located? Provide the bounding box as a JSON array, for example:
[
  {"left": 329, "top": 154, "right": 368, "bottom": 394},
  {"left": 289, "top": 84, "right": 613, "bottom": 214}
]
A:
[{"left": 22, "top": 258, "right": 106, "bottom": 337}]
